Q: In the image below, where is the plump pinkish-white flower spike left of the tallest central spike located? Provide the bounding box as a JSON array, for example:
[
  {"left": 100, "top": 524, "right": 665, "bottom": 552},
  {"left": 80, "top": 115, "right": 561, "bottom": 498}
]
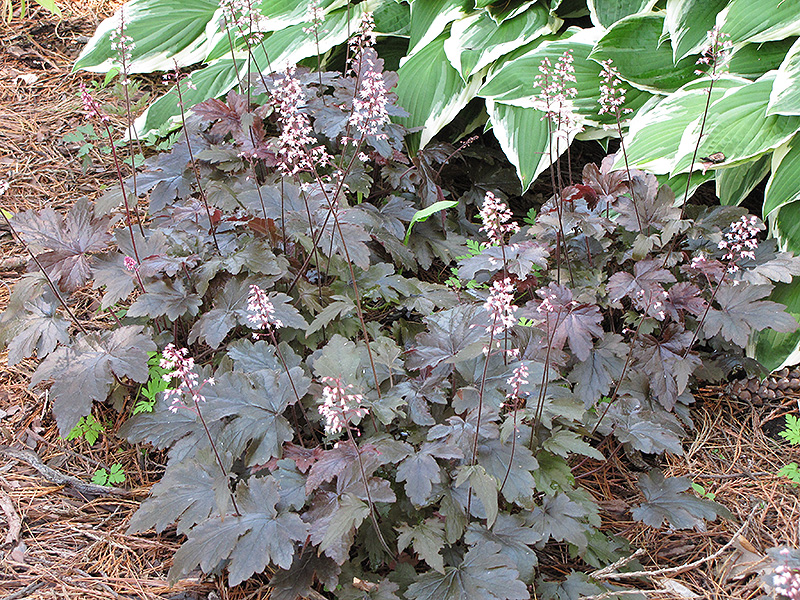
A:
[{"left": 272, "top": 66, "right": 330, "bottom": 175}]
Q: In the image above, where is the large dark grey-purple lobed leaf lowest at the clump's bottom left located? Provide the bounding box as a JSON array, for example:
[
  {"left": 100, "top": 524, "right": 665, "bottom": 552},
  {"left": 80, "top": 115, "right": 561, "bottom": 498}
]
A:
[{"left": 169, "top": 477, "right": 308, "bottom": 586}]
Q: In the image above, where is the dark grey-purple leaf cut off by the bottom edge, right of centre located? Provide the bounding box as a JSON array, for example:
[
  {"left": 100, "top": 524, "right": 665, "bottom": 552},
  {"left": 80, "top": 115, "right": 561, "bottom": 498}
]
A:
[{"left": 406, "top": 542, "right": 530, "bottom": 600}]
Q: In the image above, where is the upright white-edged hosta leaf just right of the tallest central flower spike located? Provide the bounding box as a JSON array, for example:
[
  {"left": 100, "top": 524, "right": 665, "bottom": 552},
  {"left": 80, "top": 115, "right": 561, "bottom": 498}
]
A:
[{"left": 394, "top": 36, "right": 481, "bottom": 150}]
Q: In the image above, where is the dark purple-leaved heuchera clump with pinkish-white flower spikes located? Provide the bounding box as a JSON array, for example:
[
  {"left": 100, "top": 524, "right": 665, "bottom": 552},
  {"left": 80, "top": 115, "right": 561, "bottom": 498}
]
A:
[{"left": 0, "top": 18, "right": 800, "bottom": 600}]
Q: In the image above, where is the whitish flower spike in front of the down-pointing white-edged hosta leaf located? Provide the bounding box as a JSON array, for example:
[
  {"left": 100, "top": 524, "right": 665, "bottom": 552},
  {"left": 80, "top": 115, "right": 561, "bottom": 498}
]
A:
[{"left": 533, "top": 51, "right": 583, "bottom": 136}]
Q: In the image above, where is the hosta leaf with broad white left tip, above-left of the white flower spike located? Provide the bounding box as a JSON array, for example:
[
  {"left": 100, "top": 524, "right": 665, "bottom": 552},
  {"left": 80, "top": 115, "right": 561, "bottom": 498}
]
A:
[{"left": 444, "top": 4, "right": 560, "bottom": 81}]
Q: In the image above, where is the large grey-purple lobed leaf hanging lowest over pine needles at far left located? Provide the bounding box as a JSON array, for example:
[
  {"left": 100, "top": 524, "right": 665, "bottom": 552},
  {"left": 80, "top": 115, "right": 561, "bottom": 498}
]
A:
[{"left": 31, "top": 326, "right": 156, "bottom": 436}]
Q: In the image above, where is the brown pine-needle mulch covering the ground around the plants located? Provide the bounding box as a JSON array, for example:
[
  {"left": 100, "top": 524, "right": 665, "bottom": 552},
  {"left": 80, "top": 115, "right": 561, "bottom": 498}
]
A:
[{"left": 0, "top": 0, "right": 800, "bottom": 600}]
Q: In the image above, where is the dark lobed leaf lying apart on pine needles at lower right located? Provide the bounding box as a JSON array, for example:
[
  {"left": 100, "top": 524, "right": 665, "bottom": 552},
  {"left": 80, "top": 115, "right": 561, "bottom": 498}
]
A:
[{"left": 631, "top": 469, "right": 728, "bottom": 531}]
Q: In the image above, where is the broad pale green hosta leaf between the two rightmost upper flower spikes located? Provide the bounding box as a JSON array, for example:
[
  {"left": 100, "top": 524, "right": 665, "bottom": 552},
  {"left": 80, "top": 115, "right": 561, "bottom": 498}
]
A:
[{"left": 614, "top": 77, "right": 747, "bottom": 174}]
